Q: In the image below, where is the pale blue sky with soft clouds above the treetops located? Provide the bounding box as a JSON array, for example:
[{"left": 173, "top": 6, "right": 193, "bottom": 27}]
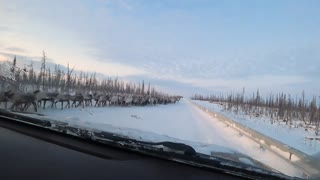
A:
[{"left": 0, "top": 0, "right": 320, "bottom": 95}]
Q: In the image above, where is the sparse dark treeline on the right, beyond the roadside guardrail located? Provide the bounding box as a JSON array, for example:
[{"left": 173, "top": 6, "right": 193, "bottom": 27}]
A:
[{"left": 192, "top": 89, "right": 320, "bottom": 134}]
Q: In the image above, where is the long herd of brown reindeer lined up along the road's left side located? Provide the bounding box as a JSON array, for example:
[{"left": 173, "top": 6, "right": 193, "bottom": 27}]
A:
[{"left": 0, "top": 90, "right": 182, "bottom": 112}]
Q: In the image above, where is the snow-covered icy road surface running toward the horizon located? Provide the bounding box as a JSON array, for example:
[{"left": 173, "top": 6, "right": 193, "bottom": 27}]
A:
[{"left": 35, "top": 100, "right": 302, "bottom": 177}]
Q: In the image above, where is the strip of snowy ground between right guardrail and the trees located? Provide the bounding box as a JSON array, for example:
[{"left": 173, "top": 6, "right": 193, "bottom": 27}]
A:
[{"left": 193, "top": 100, "right": 320, "bottom": 156}]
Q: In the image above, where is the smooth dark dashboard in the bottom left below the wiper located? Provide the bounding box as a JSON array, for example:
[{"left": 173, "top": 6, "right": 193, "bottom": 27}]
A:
[{"left": 0, "top": 121, "right": 239, "bottom": 180}]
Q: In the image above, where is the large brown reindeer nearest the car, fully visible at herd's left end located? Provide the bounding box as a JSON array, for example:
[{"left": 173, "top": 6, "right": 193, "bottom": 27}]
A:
[{"left": 7, "top": 90, "right": 40, "bottom": 112}]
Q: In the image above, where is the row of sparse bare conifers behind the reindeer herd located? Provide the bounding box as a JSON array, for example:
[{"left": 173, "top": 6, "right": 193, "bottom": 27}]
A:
[{"left": 0, "top": 53, "right": 161, "bottom": 96}]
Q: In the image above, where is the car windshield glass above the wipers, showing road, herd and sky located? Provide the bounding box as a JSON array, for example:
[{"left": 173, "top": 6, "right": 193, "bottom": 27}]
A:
[{"left": 0, "top": 0, "right": 320, "bottom": 178}]
